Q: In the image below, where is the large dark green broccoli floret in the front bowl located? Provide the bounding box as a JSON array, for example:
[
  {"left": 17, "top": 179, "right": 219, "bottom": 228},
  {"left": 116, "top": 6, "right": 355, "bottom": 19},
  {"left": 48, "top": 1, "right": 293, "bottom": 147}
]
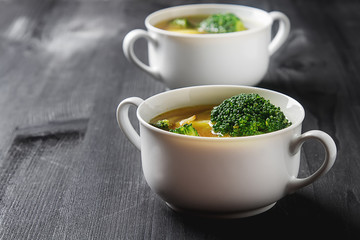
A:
[{"left": 210, "top": 93, "right": 292, "bottom": 137}]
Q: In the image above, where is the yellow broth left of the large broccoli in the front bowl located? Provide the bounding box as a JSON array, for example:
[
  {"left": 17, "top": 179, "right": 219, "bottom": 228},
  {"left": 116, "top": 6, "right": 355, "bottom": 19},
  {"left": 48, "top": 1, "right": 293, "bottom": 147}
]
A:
[{"left": 150, "top": 105, "right": 218, "bottom": 137}]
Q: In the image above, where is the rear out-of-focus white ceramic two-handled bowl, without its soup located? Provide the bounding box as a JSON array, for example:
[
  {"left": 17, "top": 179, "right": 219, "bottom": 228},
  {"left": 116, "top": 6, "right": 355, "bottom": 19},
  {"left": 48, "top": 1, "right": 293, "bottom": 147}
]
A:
[{"left": 123, "top": 4, "right": 290, "bottom": 89}]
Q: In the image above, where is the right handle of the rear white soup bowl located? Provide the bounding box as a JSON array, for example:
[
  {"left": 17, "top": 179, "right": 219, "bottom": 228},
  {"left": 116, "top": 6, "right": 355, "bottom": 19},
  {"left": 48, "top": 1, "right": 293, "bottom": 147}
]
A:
[{"left": 269, "top": 11, "right": 290, "bottom": 56}]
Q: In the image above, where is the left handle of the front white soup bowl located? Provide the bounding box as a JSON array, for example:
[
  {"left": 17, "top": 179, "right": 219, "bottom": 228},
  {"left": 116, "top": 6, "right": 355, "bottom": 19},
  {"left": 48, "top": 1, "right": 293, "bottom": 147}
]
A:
[{"left": 116, "top": 97, "right": 144, "bottom": 150}]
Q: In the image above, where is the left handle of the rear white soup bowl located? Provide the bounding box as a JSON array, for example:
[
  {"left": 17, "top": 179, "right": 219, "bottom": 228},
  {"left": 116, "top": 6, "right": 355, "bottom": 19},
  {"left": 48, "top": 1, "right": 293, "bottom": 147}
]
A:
[{"left": 123, "top": 29, "right": 161, "bottom": 80}]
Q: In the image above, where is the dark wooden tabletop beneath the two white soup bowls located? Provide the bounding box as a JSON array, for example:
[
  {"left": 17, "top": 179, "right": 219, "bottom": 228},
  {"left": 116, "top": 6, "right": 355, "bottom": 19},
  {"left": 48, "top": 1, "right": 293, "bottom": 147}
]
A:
[{"left": 0, "top": 0, "right": 360, "bottom": 240}]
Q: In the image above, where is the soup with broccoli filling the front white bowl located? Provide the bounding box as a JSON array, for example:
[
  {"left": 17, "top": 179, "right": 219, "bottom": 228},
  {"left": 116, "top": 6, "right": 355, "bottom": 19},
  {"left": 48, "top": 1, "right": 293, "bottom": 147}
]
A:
[{"left": 150, "top": 93, "right": 292, "bottom": 137}]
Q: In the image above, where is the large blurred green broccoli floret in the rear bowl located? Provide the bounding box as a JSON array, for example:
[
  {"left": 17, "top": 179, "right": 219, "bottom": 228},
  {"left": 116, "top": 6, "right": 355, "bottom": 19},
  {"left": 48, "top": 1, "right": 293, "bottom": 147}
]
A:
[{"left": 199, "top": 13, "right": 246, "bottom": 33}]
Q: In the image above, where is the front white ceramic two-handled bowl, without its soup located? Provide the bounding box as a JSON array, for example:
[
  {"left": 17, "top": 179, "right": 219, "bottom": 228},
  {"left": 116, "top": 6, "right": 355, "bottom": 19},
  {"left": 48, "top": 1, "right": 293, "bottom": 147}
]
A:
[{"left": 116, "top": 85, "right": 337, "bottom": 217}]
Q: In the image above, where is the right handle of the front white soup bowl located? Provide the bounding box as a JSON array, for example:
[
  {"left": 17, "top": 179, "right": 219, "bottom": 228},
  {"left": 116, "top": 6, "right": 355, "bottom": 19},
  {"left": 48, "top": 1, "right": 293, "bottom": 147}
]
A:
[{"left": 287, "top": 130, "right": 337, "bottom": 193}]
